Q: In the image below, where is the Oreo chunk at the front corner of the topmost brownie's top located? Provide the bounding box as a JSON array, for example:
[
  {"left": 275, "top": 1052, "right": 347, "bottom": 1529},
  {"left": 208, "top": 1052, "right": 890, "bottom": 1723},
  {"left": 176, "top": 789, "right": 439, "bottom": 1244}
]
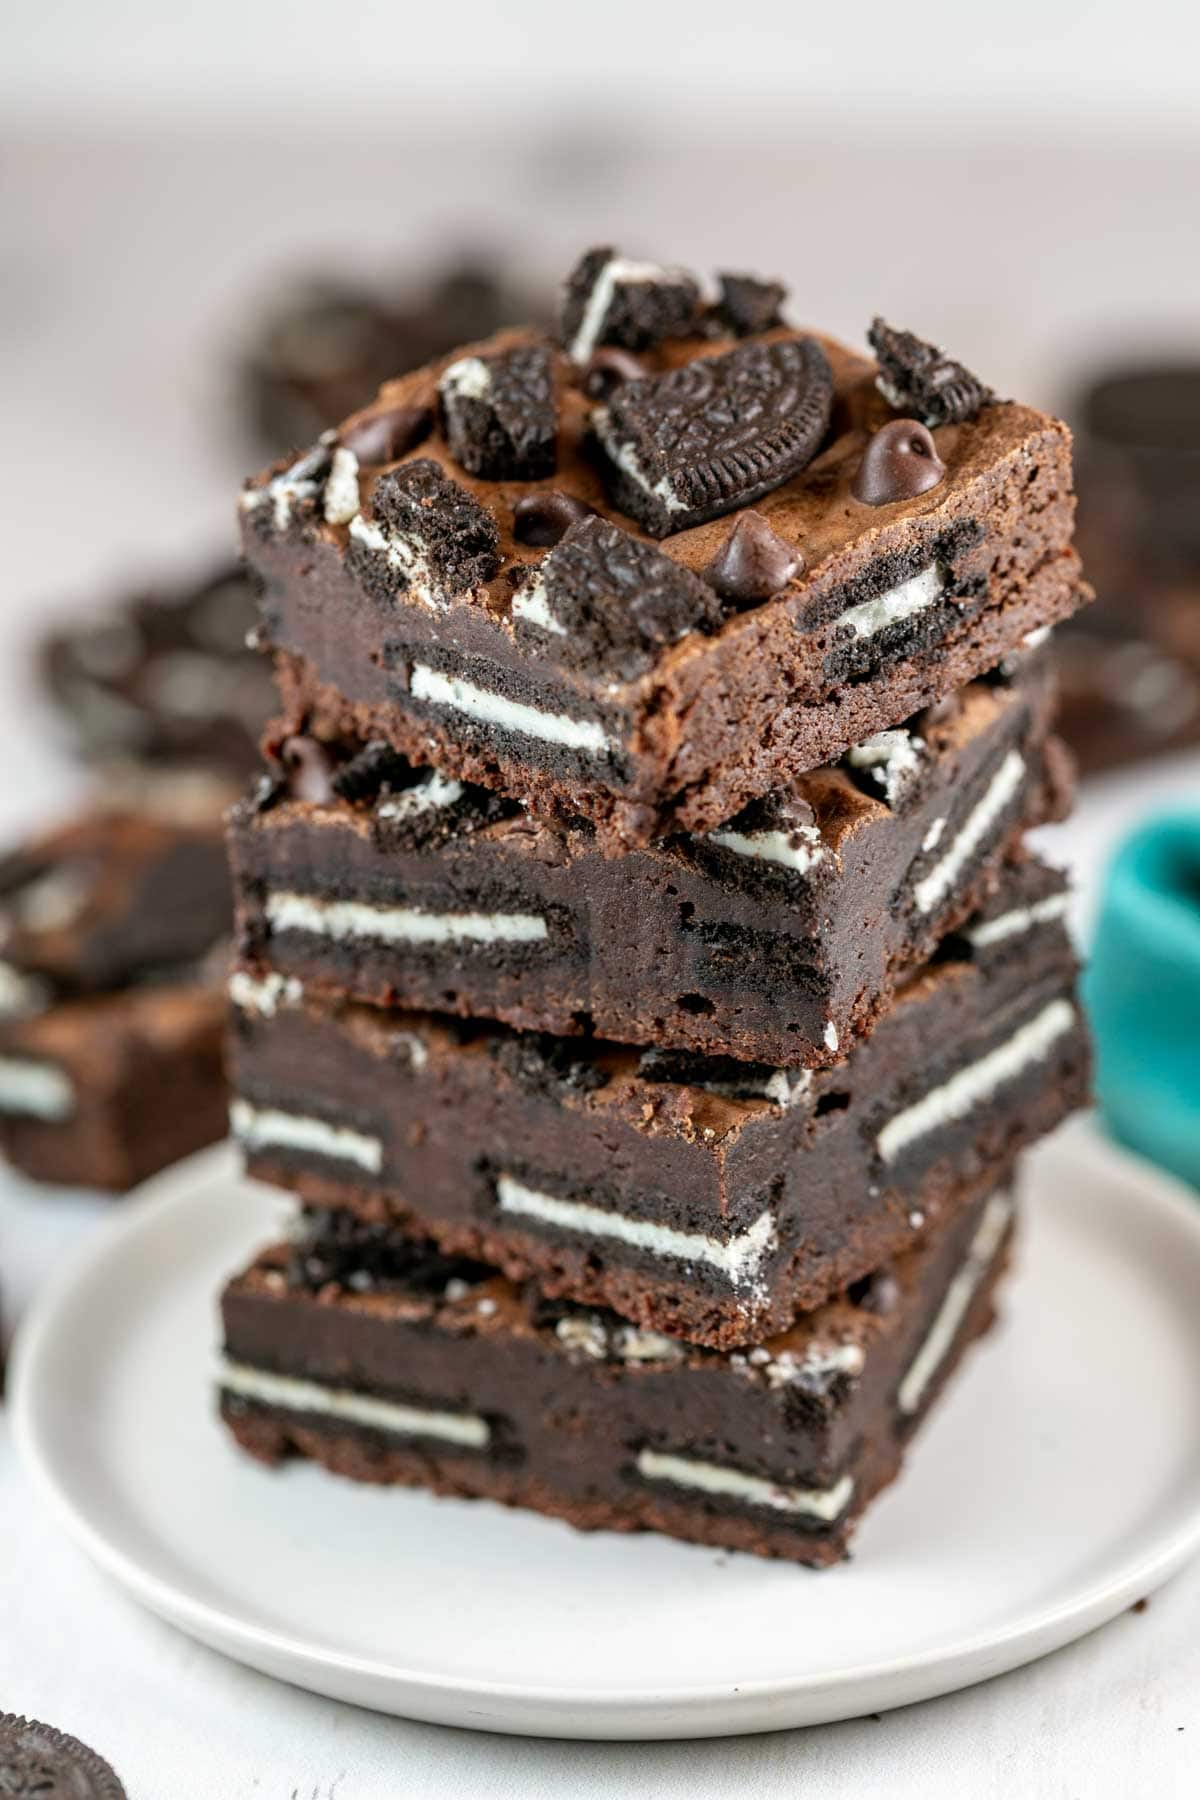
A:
[{"left": 513, "top": 517, "right": 725, "bottom": 680}]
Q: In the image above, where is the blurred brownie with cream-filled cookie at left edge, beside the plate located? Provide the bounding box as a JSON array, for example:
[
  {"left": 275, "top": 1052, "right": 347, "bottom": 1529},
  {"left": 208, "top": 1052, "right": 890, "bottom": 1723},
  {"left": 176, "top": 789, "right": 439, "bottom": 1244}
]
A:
[{"left": 0, "top": 810, "right": 230, "bottom": 1192}]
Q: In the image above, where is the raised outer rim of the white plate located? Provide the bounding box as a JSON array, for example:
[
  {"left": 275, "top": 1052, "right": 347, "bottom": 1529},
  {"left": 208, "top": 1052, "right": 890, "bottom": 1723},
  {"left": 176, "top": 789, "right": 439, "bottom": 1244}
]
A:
[{"left": 9, "top": 1114, "right": 1200, "bottom": 1739}]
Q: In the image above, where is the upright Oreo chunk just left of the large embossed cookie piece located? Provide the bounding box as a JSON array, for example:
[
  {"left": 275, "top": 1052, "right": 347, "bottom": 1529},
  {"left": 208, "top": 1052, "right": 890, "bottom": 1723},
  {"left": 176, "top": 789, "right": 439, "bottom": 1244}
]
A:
[{"left": 437, "top": 344, "right": 558, "bottom": 481}]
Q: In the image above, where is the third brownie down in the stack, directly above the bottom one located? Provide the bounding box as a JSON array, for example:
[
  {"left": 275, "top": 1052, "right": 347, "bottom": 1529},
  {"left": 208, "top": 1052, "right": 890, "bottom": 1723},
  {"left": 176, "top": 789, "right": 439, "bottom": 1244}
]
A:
[{"left": 230, "top": 860, "right": 1088, "bottom": 1348}]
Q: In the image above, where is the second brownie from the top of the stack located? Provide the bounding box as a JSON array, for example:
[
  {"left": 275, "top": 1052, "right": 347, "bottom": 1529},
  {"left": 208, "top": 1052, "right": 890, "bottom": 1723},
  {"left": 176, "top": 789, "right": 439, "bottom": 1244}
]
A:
[{"left": 230, "top": 652, "right": 1067, "bottom": 1067}]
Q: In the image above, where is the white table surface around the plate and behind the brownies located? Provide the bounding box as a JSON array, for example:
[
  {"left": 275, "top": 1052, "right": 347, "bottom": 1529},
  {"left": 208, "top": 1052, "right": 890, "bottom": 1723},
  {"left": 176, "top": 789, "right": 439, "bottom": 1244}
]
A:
[{"left": 0, "top": 119, "right": 1200, "bottom": 1800}]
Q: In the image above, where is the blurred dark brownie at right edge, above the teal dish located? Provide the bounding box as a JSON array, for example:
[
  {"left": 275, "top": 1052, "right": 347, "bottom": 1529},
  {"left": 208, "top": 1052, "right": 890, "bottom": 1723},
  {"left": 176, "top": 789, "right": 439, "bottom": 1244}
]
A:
[{"left": 1056, "top": 364, "right": 1200, "bottom": 774}]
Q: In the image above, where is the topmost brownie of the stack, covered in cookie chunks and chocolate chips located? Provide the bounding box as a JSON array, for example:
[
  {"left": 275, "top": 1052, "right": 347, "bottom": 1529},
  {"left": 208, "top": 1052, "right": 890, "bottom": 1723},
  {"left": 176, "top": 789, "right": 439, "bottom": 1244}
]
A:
[{"left": 241, "top": 250, "right": 1087, "bottom": 850}]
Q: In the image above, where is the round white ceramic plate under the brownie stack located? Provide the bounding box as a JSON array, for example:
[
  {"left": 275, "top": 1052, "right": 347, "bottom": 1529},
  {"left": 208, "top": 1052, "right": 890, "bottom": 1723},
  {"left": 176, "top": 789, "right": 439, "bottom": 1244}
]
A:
[{"left": 13, "top": 1121, "right": 1200, "bottom": 1737}]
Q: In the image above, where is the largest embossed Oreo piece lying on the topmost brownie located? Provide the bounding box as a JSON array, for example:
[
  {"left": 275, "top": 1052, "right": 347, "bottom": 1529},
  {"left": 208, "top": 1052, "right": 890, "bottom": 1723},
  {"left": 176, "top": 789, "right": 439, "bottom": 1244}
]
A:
[{"left": 592, "top": 338, "right": 833, "bottom": 538}]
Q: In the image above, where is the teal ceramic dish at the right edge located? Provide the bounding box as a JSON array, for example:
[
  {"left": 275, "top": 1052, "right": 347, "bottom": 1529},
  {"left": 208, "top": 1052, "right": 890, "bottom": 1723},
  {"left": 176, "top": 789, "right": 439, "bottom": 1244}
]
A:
[{"left": 1083, "top": 812, "right": 1200, "bottom": 1188}]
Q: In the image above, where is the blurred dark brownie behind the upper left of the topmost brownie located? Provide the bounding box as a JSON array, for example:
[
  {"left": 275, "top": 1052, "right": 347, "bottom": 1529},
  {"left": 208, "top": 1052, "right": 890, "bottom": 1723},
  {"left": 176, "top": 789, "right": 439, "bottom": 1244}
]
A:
[{"left": 241, "top": 254, "right": 549, "bottom": 452}]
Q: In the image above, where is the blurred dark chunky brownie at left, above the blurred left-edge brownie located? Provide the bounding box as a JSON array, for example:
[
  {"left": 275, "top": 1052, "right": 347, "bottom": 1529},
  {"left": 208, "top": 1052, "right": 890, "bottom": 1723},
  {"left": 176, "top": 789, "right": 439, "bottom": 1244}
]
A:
[{"left": 41, "top": 567, "right": 273, "bottom": 779}]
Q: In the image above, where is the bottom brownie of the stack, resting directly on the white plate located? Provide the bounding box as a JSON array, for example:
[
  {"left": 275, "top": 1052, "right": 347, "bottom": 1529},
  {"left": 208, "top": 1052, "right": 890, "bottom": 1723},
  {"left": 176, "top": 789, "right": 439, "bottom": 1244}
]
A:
[{"left": 218, "top": 1186, "right": 1013, "bottom": 1566}]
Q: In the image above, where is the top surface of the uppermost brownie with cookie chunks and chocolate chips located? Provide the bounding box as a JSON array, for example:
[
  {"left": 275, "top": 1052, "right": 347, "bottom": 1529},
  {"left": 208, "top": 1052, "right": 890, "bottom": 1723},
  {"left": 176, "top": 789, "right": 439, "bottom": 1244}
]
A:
[{"left": 241, "top": 252, "right": 1069, "bottom": 704}]
